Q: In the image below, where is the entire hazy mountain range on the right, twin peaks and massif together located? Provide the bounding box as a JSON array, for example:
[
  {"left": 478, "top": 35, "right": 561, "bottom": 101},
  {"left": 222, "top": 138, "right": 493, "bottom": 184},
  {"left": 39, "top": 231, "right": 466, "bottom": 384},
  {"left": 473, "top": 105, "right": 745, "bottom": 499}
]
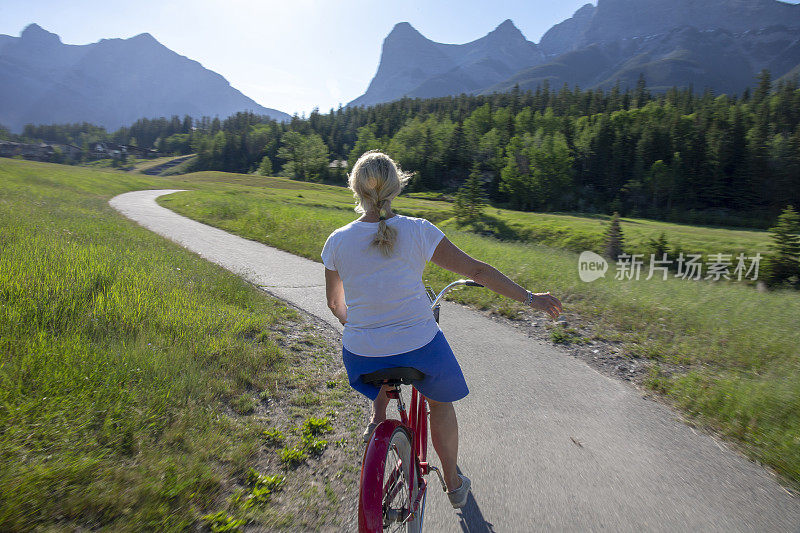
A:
[{"left": 350, "top": 0, "right": 800, "bottom": 105}]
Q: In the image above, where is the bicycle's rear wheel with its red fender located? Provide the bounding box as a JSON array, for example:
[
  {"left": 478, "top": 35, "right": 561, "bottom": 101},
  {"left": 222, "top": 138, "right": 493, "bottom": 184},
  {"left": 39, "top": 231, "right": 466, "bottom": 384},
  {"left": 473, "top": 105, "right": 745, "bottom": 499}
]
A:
[{"left": 358, "top": 420, "right": 424, "bottom": 533}]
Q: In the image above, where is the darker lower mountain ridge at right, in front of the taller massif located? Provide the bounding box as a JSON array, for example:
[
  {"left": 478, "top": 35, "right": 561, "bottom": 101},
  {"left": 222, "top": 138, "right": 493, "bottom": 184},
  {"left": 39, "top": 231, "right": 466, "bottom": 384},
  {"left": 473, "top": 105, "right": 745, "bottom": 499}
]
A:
[{"left": 482, "top": 27, "right": 800, "bottom": 94}]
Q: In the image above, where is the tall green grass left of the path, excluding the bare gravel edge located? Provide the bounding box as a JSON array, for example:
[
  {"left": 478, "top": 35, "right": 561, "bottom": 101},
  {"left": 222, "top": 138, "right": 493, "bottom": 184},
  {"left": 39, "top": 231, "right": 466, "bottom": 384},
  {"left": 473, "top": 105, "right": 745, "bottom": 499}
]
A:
[{"left": 0, "top": 160, "right": 316, "bottom": 531}]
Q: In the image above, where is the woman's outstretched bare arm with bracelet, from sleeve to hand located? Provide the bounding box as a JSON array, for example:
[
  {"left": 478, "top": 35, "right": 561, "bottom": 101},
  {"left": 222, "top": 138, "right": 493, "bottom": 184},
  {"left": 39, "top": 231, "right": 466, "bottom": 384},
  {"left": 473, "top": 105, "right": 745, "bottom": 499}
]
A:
[{"left": 431, "top": 237, "right": 562, "bottom": 320}]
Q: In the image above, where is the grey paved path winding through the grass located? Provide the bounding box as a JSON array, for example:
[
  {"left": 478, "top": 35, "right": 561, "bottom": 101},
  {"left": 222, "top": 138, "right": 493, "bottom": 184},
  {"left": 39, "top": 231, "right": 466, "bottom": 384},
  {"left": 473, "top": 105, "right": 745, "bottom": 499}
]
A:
[{"left": 110, "top": 190, "right": 800, "bottom": 533}]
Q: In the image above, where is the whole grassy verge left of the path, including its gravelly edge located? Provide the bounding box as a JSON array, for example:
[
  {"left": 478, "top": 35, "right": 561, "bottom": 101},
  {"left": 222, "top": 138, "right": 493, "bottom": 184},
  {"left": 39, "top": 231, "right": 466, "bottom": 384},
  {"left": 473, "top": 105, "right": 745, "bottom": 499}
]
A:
[{"left": 0, "top": 159, "right": 359, "bottom": 531}]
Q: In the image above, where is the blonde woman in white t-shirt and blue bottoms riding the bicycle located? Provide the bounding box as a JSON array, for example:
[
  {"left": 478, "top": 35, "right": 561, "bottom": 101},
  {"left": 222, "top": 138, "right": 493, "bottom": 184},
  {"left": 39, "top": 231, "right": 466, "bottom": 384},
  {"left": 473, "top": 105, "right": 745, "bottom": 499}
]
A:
[{"left": 322, "top": 151, "right": 561, "bottom": 508}]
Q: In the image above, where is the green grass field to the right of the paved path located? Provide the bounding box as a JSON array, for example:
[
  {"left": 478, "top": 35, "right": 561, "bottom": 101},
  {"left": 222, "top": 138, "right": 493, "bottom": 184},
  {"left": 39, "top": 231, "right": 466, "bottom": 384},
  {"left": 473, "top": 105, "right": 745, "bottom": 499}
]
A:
[{"left": 159, "top": 173, "right": 800, "bottom": 483}]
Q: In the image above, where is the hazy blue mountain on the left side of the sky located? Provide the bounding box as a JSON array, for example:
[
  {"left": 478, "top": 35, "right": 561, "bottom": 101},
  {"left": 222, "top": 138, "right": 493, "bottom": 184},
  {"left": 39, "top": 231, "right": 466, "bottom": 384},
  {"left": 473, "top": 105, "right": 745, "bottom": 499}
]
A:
[{"left": 0, "top": 24, "right": 290, "bottom": 131}]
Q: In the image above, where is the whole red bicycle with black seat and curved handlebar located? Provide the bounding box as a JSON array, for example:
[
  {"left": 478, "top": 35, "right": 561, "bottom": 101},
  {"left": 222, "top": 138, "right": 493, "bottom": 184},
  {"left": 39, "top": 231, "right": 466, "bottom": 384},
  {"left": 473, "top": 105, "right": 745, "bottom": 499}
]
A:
[{"left": 358, "top": 279, "right": 483, "bottom": 533}]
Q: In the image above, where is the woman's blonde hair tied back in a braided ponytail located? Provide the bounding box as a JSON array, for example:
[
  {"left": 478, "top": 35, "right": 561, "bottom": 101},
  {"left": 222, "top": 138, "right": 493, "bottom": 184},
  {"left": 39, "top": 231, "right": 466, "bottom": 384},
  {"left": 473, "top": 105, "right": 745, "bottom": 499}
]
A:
[{"left": 347, "top": 150, "right": 410, "bottom": 257}]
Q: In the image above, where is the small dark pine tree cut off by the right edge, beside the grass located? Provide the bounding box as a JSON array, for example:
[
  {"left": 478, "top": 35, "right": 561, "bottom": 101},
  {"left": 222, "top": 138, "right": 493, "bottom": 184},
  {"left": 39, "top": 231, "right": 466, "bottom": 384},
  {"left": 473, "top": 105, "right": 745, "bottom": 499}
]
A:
[{"left": 766, "top": 205, "right": 800, "bottom": 286}]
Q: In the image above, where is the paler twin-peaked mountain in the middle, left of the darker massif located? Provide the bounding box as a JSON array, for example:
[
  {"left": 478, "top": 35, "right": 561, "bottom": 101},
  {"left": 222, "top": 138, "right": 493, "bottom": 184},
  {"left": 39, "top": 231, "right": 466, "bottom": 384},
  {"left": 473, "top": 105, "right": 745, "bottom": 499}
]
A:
[{"left": 348, "top": 20, "right": 544, "bottom": 105}]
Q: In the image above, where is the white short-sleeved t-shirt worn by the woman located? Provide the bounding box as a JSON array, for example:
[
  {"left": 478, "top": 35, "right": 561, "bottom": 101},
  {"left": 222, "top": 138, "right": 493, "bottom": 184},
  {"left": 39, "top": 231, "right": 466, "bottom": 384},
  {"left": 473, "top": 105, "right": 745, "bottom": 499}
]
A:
[{"left": 322, "top": 214, "right": 444, "bottom": 356}]
